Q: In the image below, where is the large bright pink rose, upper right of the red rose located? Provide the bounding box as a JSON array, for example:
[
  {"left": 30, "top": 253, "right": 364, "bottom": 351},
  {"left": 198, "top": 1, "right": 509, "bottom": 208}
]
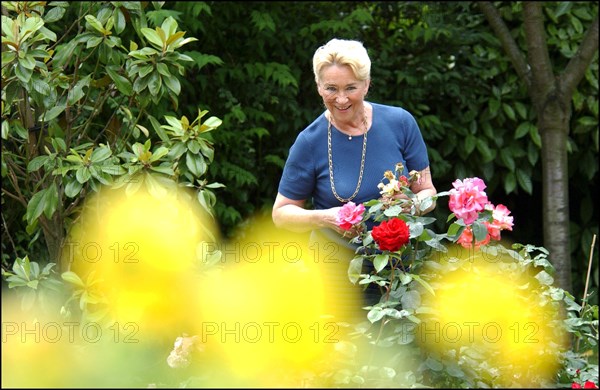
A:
[{"left": 448, "top": 177, "right": 489, "bottom": 225}]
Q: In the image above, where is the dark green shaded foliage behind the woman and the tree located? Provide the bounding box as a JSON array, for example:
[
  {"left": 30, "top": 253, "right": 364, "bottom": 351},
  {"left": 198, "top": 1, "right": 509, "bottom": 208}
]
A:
[{"left": 2, "top": 2, "right": 598, "bottom": 299}]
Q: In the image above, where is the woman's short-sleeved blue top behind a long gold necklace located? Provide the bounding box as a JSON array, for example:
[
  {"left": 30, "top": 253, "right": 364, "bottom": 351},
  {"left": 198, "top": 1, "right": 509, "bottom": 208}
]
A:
[{"left": 278, "top": 103, "right": 429, "bottom": 209}]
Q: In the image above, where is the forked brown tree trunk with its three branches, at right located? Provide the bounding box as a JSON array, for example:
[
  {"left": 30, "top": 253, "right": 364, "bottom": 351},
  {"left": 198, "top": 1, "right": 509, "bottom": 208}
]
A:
[{"left": 479, "top": 1, "right": 598, "bottom": 291}]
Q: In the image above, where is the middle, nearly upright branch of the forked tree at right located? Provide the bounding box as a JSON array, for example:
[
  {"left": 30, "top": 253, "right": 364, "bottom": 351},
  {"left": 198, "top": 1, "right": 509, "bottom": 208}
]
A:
[{"left": 523, "top": 1, "right": 556, "bottom": 99}]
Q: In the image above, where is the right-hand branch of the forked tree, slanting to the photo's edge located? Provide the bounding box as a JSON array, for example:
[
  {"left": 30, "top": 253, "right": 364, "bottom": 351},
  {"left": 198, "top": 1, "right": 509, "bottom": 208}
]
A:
[{"left": 559, "top": 14, "right": 598, "bottom": 99}]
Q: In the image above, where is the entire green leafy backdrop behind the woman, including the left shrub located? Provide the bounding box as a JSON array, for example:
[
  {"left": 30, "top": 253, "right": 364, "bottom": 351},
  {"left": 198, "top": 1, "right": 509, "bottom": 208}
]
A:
[{"left": 2, "top": 2, "right": 598, "bottom": 385}]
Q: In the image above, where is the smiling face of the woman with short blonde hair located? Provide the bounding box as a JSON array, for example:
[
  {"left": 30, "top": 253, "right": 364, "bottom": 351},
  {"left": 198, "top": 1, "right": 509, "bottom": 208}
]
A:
[{"left": 318, "top": 65, "right": 369, "bottom": 120}]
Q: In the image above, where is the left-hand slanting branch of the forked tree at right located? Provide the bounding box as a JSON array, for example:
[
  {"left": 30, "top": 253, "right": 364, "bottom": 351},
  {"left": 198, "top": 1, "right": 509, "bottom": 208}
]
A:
[{"left": 477, "top": 1, "right": 531, "bottom": 89}]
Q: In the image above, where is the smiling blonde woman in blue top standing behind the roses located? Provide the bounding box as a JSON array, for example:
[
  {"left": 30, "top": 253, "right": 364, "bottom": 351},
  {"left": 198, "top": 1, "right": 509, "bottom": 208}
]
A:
[{"left": 272, "top": 39, "right": 437, "bottom": 320}]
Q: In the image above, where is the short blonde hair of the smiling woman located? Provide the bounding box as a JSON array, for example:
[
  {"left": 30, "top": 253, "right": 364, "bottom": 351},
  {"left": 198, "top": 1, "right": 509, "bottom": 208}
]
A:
[{"left": 313, "top": 38, "right": 371, "bottom": 84}]
